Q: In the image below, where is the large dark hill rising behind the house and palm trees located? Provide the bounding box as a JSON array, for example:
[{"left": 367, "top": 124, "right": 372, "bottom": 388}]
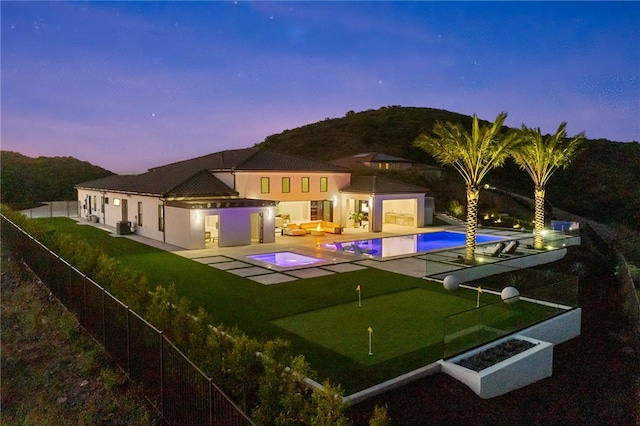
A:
[{"left": 257, "top": 106, "right": 640, "bottom": 230}]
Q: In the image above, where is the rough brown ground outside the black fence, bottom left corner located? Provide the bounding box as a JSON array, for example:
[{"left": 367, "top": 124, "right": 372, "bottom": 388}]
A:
[{"left": 0, "top": 245, "right": 159, "bottom": 426}]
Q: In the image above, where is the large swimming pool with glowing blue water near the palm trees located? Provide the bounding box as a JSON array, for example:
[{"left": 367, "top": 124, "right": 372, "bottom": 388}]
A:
[{"left": 322, "top": 231, "right": 505, "bottom": 258}]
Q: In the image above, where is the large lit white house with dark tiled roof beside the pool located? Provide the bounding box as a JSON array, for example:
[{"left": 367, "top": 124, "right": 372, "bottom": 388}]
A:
[{"left": 75, "top": 147, "right": 432, "bottom": 249}]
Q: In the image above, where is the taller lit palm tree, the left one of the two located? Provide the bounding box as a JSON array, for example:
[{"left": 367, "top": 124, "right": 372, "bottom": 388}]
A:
[{"left": 415, "top": 112, "right": 520, "bottom": 261}]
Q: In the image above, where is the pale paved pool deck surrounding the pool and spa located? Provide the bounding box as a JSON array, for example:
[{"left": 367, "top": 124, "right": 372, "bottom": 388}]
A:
[{"left": 78, "top": 220, "right": 579, "bottom": 285}]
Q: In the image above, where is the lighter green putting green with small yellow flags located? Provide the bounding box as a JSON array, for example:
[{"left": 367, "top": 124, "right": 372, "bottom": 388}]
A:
[{"left": 272, "top": 285, "right": 473, "bottom": 365}]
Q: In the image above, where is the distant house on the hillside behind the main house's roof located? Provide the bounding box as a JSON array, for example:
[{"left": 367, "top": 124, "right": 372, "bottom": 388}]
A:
[{"left": 331, "top": 152, "right": 442, "bottom": 179}]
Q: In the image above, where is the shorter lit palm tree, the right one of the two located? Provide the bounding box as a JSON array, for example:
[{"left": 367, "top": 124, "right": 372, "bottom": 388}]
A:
[{"left": 512, "top": 122, "right": 584, "bottom": 249}]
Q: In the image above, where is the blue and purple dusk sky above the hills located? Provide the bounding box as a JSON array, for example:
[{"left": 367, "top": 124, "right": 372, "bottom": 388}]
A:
[{"left": 0, "top": 1, "right": 640, "bottom": 173}]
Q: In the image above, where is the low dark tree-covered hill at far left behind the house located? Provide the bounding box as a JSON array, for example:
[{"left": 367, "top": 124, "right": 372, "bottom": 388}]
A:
[{"left": 0, "top": 151, "right": 113, "bottom": 209}]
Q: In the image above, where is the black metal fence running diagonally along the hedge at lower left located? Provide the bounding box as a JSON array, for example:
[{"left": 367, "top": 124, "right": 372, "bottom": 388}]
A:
[{"left": 2, "top": 216, "right": 254, "bottom": 426}]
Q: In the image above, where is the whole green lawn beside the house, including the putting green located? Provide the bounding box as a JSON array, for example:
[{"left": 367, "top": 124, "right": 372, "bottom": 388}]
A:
[{"left": 38, "top": 218, "right": 564, "bottom": 394}]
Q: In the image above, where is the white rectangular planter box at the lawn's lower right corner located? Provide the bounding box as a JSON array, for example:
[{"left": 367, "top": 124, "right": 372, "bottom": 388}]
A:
[{"left": 440, "top": 335, "right": 553, "bottom": 399}]
